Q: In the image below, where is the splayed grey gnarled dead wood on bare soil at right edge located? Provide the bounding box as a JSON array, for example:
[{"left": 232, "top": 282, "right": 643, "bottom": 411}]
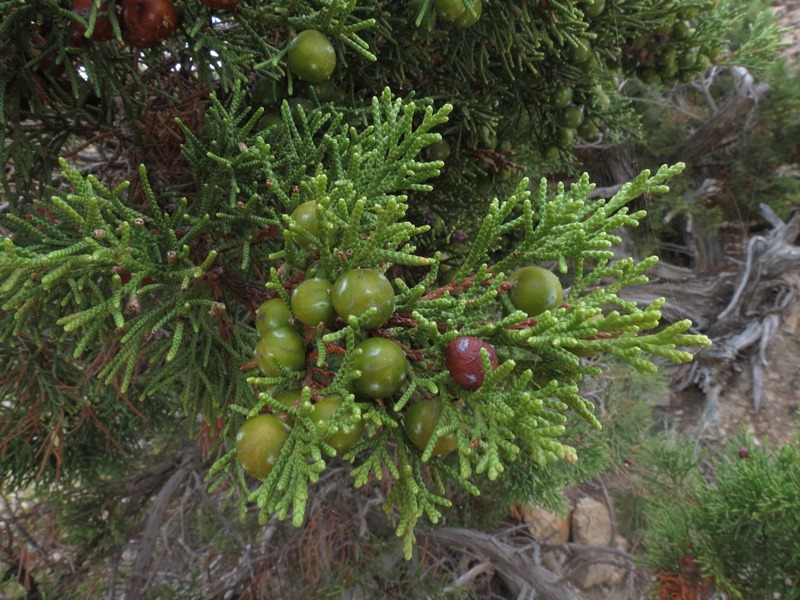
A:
[{"left": 627, "top": 204, "right": 800, "bottom": 427}]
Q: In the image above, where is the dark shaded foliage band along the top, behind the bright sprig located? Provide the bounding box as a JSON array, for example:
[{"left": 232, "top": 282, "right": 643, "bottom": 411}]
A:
[{"left": 0, "top": 0, "right": 774, "bottom": 205}]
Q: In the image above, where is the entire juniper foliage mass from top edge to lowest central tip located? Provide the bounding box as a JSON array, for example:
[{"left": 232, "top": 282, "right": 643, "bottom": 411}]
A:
[{"left": 0, "top": 0, "right": 776, "bottom": 580}]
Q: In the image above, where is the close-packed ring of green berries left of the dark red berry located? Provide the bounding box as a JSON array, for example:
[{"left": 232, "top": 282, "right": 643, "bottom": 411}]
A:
[{"left": 241, "top": 262, "right": 409, "bottom": 479}]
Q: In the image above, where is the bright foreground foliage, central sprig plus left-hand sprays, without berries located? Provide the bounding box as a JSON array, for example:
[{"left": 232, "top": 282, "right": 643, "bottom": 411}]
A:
[{"left": 0, "top": 75, "right": 707, "bottom": 555}]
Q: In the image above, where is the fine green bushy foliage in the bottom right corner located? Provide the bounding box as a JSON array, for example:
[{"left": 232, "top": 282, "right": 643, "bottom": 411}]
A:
[{"left": 639, "top": 433, "right": 800, "bottom": 600}]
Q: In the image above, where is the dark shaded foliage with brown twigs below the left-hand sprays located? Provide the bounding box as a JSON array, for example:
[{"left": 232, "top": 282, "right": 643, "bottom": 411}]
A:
[{"left": 0, "top": 330, "right": 182, "bottom": 490}]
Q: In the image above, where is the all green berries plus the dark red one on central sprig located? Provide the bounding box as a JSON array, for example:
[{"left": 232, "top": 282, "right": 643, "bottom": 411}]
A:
[{"left": 236, "top": 202, "right": 563, "bottom": 479}]
